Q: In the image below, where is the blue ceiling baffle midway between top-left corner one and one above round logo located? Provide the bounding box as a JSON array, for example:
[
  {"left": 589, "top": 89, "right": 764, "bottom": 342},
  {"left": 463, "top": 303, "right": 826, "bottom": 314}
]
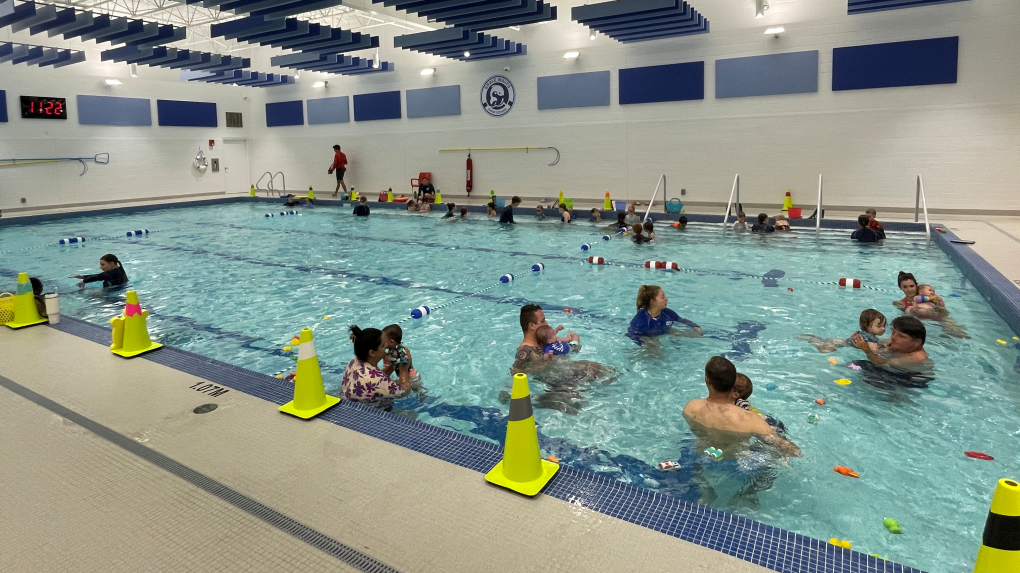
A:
[{"left": 209, "top": 16, "right": 379, "bottom": 54}]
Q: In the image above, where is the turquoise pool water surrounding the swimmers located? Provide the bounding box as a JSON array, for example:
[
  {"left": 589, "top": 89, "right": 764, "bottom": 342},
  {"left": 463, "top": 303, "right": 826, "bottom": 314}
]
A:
[{"left": 0, "top": 204, "right": 1020, "bottom": 573}]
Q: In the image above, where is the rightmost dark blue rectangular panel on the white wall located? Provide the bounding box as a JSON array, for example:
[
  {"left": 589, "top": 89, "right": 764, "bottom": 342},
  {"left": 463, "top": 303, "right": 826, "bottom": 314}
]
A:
[{"left": 832, "top": 36, "right": 960, "bottom": 92}]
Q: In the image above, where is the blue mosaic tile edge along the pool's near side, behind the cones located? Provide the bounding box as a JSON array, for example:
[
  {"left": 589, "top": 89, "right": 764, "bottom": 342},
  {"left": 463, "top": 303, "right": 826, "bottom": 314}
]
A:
[{"left": 43, "top": 314, "right": 930, "bottom": 573}]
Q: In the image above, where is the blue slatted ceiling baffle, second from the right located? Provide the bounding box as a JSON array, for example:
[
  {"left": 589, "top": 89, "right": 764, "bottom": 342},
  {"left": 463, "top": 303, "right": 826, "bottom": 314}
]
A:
[{"left": 570, "top": 0, "right": 709, "bottom": 43}]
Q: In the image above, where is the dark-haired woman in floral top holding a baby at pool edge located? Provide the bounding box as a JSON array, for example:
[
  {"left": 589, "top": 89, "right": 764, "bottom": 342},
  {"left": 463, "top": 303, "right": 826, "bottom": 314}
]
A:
[{"left": 340, "top": 326, "right": 411, "bottom": 408}]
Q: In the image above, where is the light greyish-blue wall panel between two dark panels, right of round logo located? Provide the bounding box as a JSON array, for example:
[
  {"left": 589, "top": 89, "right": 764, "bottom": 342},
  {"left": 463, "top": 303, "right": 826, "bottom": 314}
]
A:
[{"left": 715, "top": 50, "right": 818, "bottom": 98}]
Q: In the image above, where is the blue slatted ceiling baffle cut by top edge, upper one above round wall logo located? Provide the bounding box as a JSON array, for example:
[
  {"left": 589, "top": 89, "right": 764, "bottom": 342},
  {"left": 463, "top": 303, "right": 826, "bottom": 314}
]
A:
[{"left": 372, "top": 0, "right": 556, "bottom": 30}]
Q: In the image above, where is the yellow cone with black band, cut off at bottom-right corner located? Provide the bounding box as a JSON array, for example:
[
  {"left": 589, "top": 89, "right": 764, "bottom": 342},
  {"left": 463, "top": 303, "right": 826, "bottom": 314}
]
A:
[{"left": 974, "top": 479, "right": 1020, "bottom": 573}]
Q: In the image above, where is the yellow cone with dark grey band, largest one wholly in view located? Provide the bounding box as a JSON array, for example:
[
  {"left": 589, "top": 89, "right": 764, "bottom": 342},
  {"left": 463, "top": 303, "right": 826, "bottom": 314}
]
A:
[{"left": 486, "top": 374, "right": 560, "bottom": 496}]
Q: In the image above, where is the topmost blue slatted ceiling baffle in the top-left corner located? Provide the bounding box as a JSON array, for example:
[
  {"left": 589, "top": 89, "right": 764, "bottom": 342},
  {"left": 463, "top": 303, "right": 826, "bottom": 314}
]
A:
[{"left": 0, "top": 0, "right": 187, "bottom": 46}]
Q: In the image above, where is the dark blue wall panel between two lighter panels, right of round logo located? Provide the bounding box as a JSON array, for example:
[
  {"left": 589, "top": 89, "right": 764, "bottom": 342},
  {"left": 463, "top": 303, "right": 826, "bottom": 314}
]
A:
[{"left": 620, "top": 61, "right": 705, "bottom": 105}]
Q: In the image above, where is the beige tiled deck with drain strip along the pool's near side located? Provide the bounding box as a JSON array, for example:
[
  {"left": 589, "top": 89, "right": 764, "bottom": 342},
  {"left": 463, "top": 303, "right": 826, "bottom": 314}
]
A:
[{"left": 0, "top": 325, "right": 764, "bottom": 573}]
